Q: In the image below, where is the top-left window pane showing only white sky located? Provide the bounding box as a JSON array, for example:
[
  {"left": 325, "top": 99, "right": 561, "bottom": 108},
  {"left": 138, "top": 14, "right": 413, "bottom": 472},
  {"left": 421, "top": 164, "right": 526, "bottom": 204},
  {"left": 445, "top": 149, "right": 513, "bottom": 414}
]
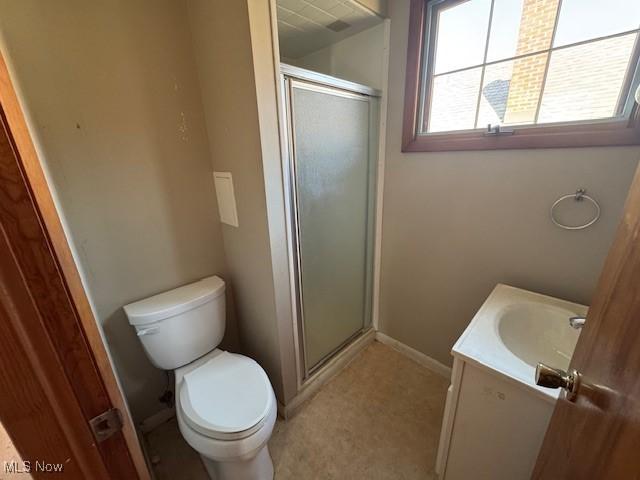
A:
[{"left": 435, "top": 0, "right": 491, "bottom": 74}]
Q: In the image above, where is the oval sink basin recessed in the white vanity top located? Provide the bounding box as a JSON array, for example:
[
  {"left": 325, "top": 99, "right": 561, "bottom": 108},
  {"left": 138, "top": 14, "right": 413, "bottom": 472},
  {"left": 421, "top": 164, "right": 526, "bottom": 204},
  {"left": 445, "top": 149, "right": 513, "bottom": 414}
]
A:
[{"left": 497, "top": 303, "right": 580, "bottom": 370}]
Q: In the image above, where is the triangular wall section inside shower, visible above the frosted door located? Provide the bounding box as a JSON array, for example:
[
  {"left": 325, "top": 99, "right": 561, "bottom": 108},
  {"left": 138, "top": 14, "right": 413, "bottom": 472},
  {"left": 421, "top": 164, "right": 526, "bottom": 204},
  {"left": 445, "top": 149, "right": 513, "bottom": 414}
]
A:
[{"left": 283, "top": 23, "right": 385, "bottom": 89}]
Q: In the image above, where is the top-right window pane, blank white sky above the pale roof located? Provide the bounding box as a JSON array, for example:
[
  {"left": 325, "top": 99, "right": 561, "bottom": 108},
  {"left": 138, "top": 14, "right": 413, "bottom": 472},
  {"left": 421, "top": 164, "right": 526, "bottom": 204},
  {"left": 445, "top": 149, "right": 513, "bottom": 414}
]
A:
[{"left": 554, "top": 0, "right": 640, "bottom": 47}]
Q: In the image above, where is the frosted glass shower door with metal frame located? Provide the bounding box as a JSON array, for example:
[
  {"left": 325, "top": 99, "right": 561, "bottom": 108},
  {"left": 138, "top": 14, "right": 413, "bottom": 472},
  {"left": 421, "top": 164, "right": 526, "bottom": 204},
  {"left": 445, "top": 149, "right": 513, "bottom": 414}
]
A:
[{"left": 282, "top": 65, "right": 379, "bottom": 381}]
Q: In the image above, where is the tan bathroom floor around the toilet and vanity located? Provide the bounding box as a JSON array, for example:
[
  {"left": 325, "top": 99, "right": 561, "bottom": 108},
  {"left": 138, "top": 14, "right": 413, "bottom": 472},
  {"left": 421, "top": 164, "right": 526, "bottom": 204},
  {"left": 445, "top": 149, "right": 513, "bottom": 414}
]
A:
[{"left": 147, "top": 342, "right": 448, "bottom": 480}]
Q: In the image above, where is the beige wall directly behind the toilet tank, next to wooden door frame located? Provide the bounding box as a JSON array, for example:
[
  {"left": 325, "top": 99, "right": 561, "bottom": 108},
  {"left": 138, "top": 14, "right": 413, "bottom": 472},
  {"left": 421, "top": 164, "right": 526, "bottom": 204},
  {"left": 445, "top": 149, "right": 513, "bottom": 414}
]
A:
[{"left": 0, "top": 0, "right": 235, "bottom": 420}]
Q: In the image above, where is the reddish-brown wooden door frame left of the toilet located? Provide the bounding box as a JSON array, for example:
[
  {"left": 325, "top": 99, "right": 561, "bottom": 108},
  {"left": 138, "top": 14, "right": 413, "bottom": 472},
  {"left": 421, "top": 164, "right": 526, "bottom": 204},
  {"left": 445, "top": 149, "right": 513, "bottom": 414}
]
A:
[{"left": 0, "top": 53, "right": 149, "bottom": 480}]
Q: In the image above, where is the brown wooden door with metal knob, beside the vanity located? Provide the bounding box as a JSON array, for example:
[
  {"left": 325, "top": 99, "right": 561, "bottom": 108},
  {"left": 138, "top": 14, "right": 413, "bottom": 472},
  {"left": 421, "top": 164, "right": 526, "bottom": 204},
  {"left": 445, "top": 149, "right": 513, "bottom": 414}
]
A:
[{"left": 532, "top": 161, "right": 640, "bottom": 480}]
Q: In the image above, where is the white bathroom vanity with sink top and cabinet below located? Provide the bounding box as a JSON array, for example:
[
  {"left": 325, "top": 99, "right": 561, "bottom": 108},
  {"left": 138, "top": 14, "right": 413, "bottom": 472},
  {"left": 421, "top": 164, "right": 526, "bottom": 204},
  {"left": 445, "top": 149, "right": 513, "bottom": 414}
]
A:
[{"left": 436, "top": 284, "right": 587, "bottom": 480}]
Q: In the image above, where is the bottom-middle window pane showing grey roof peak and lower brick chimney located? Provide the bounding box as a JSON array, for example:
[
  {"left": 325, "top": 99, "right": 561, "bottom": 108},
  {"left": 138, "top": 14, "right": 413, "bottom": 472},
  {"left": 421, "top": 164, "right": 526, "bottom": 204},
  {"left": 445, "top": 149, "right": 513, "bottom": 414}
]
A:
[{"left": 477, "top": 53, "right": 547, "bottom": 128}]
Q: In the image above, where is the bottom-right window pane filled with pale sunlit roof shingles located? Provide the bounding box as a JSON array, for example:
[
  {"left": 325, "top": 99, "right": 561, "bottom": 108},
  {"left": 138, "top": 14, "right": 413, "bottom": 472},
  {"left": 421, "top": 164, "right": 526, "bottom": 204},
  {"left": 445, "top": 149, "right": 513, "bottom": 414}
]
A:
[{"left": 539, "top": 33, "right": 636, "bottom": 123}]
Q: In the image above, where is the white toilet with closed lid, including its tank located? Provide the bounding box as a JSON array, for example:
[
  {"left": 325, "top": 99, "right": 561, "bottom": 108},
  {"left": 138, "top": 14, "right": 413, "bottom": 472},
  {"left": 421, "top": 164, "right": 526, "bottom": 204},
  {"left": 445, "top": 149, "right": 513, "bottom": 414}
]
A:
[{"left": 124, "top": 276, "right": 277, "bottom": 480}]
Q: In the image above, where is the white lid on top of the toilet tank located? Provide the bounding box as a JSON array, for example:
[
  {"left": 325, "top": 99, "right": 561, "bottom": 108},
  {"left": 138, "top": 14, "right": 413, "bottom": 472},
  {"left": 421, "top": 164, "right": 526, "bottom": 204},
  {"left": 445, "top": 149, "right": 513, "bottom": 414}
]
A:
[{"left": 124, "top": 276, "right": 224, "bottom": 325}]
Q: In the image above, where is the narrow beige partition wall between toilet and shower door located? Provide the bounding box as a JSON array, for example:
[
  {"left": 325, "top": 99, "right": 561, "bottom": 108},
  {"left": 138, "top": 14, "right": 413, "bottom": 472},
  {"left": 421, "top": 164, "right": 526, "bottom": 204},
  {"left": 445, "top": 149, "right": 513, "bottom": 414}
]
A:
[{"left": 188, "top": 0, "right": 295, "bottom": 403}]
